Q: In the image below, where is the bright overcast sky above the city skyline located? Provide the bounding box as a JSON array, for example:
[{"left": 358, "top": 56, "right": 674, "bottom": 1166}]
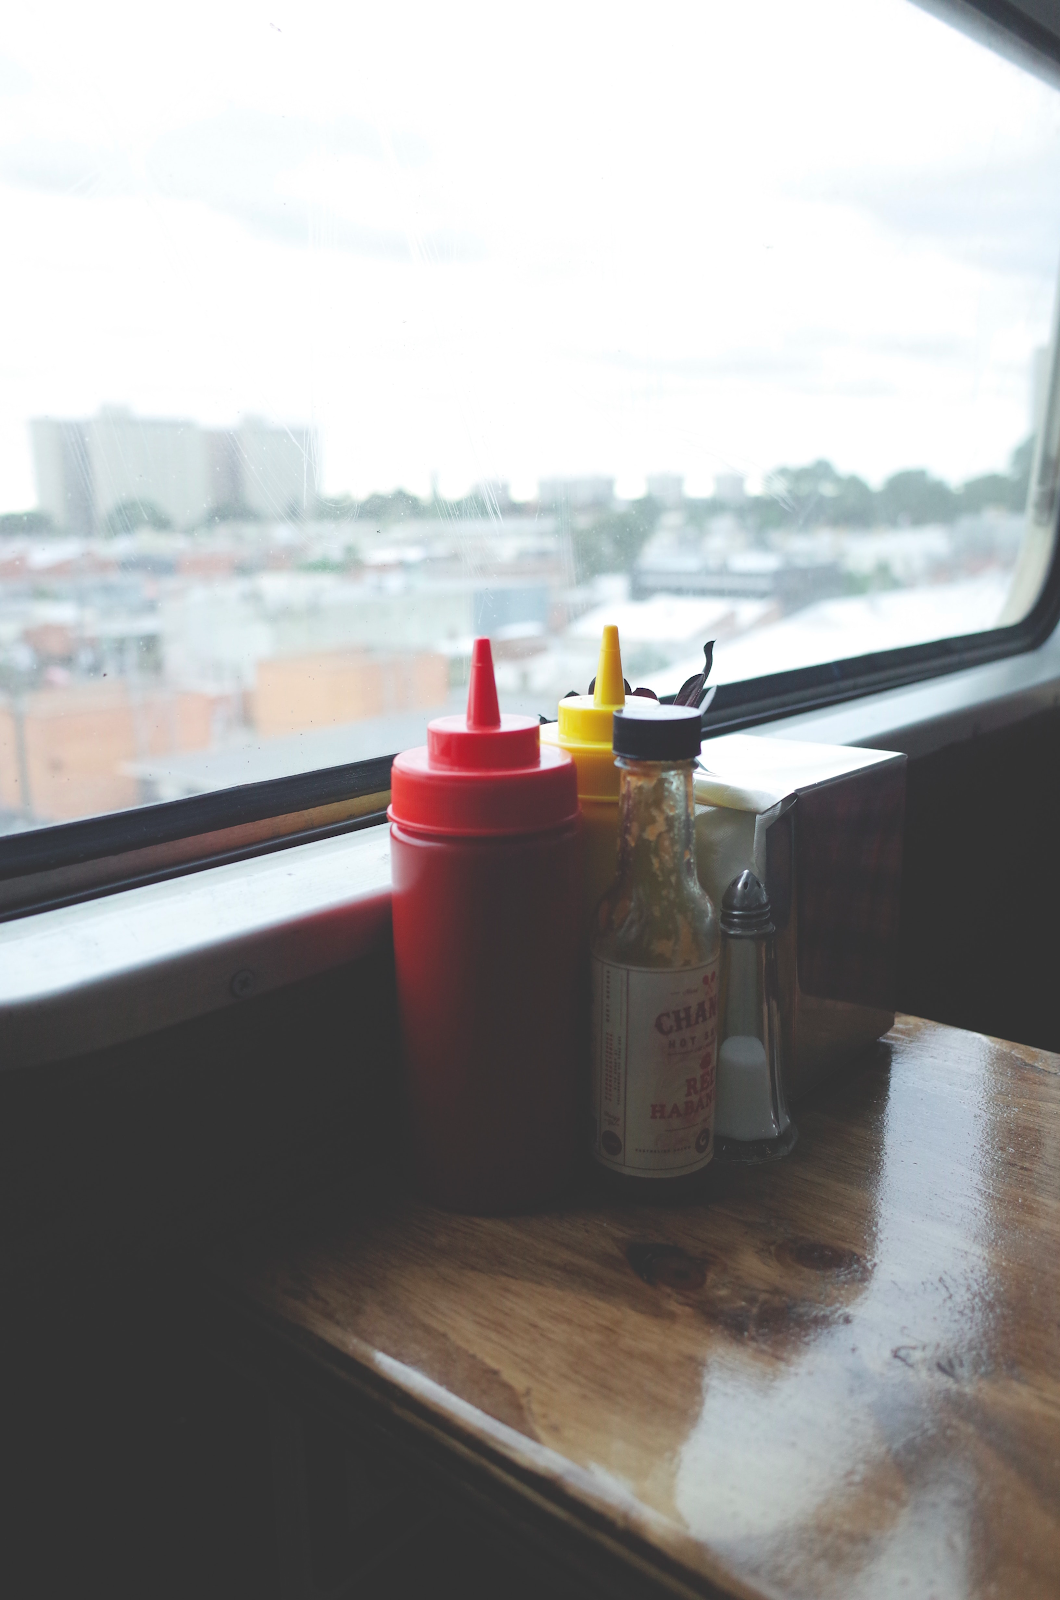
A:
[{"left": 0, "top": 0, "right": 1060, "bottom": 509}]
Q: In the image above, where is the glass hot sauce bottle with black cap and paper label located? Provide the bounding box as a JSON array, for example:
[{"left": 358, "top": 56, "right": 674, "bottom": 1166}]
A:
[{"left": 589, "top": 701, "right": 721, "bottom": 1197}]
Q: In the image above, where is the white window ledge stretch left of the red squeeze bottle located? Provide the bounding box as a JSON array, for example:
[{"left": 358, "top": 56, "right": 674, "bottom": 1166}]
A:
[{"left": 0, "top": 827, "right": 391, "bottom": 1070}]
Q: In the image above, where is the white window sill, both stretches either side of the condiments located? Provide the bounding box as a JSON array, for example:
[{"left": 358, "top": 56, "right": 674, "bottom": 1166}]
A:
[{"left": 8, "top": 635, "right": 1060, "bottom": 1070}]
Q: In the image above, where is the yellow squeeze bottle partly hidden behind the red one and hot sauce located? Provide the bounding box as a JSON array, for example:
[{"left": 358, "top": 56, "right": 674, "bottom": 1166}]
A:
[{"left": 541, "top": 624, "right": 626, "bottom": 931}]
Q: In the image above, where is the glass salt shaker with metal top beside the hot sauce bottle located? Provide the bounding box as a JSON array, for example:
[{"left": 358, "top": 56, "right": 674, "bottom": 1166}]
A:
[{"left": 714, "top": 872, "right": 797, "bottom": 1163}]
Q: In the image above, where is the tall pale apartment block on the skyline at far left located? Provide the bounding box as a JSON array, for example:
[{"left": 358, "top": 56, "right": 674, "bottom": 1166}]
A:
[{"left": 30, "top": 406, "right": 317, "bottom": 534}]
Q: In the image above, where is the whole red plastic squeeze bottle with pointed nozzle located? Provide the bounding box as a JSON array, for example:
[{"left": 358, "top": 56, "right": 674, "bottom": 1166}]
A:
[{"left": 387, "top": 638, "right": 583, "bottom": 1211}]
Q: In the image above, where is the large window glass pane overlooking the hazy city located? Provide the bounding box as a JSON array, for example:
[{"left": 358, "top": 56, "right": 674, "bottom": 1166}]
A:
[{"left": 0, "top": 0, "right": 1060, "bottom": 829}]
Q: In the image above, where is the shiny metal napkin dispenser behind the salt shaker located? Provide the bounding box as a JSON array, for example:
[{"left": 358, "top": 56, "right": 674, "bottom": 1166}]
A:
[{"left": 695, "top": 733, "right": 906, "bottom": 1101}]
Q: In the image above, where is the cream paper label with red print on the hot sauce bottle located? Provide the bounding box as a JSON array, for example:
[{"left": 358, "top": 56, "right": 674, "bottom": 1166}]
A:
[{"left": 592, "top": 957, "right": 717, "bottom": 1178}]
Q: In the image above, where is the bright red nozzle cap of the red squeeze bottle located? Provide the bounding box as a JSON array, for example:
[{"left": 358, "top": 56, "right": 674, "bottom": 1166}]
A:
[{"left": 387, "top": 638, "right": 578, "bottom": 835}]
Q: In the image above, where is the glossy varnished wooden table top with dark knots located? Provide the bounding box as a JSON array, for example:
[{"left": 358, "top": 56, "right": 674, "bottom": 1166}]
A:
[{"left": 208, "top": 1018, "right": 1060, "bottom": 1600}]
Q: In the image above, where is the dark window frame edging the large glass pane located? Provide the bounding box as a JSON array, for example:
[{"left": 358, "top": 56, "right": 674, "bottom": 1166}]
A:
[{"left": 0, "top": 0, "right": 1060, "bottom": 922}]
